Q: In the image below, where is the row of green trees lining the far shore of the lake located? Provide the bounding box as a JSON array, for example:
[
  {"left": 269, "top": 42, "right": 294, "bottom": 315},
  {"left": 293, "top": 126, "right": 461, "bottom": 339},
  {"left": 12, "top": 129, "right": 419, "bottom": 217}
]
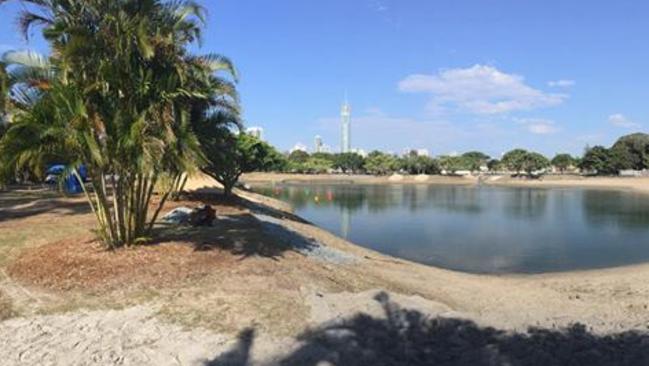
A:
[{"left": 257, "top": 133, "right": 649, "bottom": 176}]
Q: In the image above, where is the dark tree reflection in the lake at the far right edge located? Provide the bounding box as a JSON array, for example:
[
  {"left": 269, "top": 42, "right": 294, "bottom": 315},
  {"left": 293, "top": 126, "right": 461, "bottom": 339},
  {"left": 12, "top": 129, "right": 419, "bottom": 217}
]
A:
[{"left": 581, "top": 190, "right": 649, "bottom": 230}]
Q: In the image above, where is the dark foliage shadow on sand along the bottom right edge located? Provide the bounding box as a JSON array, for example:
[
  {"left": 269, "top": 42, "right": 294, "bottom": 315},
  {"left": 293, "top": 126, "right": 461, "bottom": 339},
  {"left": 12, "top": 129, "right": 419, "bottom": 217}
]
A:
[{"left": 205, "top": 293, "right": 649, "bottom": 366}]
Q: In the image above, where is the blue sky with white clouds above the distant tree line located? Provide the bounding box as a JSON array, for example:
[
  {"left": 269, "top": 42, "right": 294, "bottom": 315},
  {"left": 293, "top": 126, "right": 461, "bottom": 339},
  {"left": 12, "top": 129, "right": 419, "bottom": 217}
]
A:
[{"left": 0, "top": 0, "right": 649, "bottom": 156}]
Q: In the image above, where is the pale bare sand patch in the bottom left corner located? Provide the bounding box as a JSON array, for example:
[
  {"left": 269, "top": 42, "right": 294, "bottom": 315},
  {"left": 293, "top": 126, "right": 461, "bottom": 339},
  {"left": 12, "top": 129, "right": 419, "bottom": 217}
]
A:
[{"left": 0, "top": 306, "right": 228, "bottom": 366}]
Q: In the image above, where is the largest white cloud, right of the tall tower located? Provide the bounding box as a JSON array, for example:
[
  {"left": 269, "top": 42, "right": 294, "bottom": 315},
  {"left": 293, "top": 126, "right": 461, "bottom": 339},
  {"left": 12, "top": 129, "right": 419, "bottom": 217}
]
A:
[{"left": 399, "top": 65, "right": 568, "bottom": 114}]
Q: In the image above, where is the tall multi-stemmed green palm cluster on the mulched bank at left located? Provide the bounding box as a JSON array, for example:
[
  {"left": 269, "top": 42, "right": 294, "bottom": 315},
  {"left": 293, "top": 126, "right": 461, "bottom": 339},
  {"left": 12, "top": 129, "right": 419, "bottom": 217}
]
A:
[{"left": 0, "top": 0, "right": 239, "bottom": 248}]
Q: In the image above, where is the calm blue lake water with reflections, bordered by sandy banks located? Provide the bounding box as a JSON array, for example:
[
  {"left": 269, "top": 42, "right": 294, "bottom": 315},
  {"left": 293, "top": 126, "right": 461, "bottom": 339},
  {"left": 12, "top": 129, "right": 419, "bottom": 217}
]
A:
[{"left": 249, "top": 184, "right": 649, "bottom": 273}]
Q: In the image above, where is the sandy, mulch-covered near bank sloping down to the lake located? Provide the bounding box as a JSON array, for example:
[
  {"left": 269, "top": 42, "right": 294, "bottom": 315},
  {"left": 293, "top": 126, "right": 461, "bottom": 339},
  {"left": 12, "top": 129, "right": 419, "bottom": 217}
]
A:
[{"left": 0, "top": 181, "right": 649, "bottom": 366}]
